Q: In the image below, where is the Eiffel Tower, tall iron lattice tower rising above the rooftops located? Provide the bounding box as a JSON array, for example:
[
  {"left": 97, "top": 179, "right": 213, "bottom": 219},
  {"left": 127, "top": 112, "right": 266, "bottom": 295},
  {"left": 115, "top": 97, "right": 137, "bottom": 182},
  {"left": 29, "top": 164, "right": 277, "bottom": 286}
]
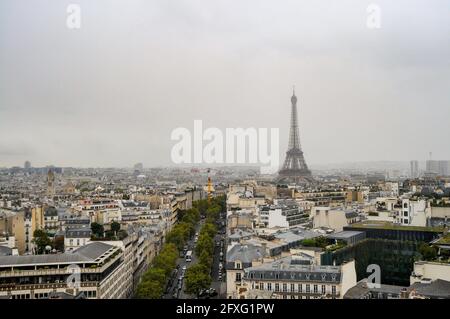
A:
[{"left": 278, "top": 89, "right": 314, "bottom": 183}]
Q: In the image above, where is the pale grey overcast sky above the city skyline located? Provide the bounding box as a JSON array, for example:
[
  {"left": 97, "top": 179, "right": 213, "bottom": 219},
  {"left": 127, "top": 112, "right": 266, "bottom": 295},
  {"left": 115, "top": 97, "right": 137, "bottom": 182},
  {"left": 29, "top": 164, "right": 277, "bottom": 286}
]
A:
[{"left": 0, "top": 0, "right": 450, "bottom": 167}]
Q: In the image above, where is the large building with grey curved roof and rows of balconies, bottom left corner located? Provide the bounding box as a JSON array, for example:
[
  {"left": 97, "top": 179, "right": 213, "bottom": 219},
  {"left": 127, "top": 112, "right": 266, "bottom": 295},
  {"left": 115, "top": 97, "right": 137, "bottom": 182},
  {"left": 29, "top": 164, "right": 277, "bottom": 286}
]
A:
[{"left": 0, "top": 242, "right": 131, "bottom": 299}]
